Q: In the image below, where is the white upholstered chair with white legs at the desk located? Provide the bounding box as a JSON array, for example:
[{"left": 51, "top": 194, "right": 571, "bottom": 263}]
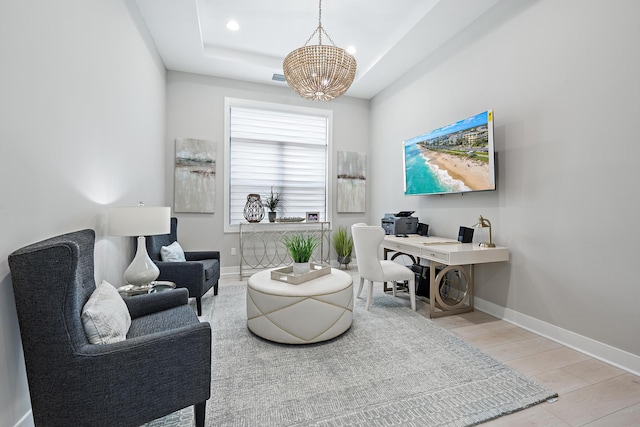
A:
[{"left": 351, "top": 223, "right": 416, "bottom": 310}]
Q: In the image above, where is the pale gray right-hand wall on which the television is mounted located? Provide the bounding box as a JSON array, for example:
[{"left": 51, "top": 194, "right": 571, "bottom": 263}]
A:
[{"left": 369, "top": 0, "right": 640, "bottom": 372}]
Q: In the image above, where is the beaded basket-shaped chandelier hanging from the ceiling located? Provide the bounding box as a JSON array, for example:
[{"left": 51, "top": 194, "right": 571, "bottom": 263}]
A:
[{"left": 282, "top": 0, "right": 356, "bottom": 101}]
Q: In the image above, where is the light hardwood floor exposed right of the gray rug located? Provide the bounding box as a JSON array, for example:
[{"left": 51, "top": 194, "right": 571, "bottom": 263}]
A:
[{"left": 418, "top": 302, "right": 640, "bottom": 427}]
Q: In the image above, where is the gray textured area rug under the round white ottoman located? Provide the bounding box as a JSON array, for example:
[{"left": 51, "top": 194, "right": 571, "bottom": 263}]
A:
[{"left": 148, "top": 282, "right": 556, "bottom": 427}]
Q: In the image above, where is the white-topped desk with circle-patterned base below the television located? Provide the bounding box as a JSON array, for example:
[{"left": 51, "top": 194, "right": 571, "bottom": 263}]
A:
[{"left": 382, "top": 235, "right": 509, "bottom": 318}]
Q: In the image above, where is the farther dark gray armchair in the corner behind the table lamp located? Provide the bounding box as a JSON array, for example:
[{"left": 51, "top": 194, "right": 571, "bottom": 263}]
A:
[{"left": 145, "top": 218, "right": 220, "bottom": 316}]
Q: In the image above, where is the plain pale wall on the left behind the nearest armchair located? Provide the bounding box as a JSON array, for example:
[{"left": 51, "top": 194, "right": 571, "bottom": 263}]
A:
[{"left": 0, "top": 0, "right": 166, "bottom": 426}]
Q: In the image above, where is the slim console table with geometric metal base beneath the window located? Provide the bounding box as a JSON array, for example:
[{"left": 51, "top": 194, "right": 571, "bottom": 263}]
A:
[{"left": 239, "top": 221, "right": 331, "bottom": 278}]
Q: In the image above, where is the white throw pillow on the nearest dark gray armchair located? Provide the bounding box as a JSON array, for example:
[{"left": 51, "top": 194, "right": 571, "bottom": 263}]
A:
[{"left": 82, "top": 280, "right": 131, "bottom": 344}]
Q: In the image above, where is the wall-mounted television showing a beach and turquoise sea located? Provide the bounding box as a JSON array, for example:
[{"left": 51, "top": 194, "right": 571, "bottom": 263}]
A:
[{"left": 402, "top": 110, "right": 496, "bottom": 195}]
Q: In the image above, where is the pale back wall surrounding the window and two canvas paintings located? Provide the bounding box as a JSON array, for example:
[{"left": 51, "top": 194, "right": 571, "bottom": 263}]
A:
[{"left": 165, "top": 71, "right": 370, "bottom": 273}]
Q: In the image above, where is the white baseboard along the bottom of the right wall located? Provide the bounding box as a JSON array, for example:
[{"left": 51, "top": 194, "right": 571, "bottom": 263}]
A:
[{"left": 474, "top": 297, "right": 640, "bottom": 375}]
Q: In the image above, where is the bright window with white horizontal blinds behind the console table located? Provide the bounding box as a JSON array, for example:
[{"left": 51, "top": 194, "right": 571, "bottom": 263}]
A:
[{"left": 225, "top": 99, "right": 332, "bottom": 231}]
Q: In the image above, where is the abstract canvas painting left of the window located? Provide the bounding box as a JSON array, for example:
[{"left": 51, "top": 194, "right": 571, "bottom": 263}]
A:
[{"left": 173, "top": 138, "right": 216, "bottom": 213}]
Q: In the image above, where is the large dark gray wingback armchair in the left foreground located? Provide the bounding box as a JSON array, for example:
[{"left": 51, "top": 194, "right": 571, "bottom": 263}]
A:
[{"left": 9, "top": 230, "right": 211, "bottom": 426}]
